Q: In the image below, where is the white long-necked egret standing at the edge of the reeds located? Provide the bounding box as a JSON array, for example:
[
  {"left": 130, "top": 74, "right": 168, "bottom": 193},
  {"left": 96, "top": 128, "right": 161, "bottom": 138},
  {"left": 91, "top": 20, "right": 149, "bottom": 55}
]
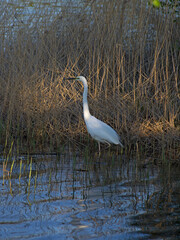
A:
[{"left": 67, "top": 76, "right": 123, "bottom": 155}]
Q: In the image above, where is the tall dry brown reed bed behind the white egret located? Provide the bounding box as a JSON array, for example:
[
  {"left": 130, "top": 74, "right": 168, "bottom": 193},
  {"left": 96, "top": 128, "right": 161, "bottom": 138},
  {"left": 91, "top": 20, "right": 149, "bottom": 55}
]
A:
[{"left": 0, "top": 0, "right": 180, "bottom": 158}]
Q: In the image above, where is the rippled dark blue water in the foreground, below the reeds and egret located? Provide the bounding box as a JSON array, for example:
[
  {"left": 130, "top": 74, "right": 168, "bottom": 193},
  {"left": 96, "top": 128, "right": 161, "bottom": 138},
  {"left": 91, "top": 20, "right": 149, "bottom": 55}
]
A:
[{"left": 0, "top": 150, "right": 180, "bottom": 240}]
